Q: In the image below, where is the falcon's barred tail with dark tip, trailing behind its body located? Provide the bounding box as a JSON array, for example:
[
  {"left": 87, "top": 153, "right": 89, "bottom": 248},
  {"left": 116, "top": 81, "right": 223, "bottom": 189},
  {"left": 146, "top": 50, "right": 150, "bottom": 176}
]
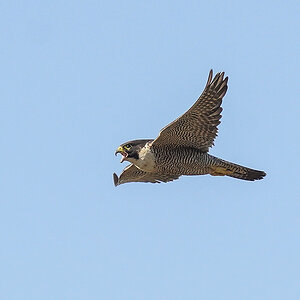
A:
[{"left": 210, "top": 159, "right": 266, "bottom": 181}]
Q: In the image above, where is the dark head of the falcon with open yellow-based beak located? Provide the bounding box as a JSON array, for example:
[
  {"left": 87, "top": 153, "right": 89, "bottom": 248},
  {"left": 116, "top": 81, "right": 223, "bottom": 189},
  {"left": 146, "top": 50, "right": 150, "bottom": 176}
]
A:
[{"left": 115, "top": 140, "right": 153, "bottom": 163}]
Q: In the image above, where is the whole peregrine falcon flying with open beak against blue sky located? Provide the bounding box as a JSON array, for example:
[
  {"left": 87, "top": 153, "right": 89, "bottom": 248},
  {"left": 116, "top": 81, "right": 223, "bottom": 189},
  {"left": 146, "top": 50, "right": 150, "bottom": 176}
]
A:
[{"left": 113, "top": 70, "right": 266, "bottom": 186}]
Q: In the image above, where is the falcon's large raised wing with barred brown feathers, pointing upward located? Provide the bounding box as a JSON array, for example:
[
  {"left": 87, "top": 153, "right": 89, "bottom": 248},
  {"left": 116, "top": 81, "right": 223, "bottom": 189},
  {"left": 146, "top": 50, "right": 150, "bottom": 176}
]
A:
[{"left": 153, "top": 70, "right": 228, "bottom": 152}]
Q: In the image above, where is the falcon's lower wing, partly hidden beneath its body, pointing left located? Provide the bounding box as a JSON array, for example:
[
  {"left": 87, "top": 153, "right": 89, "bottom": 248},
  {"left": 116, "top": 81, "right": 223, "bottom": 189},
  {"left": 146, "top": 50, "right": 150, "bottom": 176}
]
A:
[{"left": 113, "top": 164, "right": 180, "bottom": 186}]
